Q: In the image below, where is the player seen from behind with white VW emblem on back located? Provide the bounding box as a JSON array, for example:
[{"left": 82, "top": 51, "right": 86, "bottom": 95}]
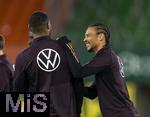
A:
[{"left": 14, "top": 12, "right": 77, "bottom": 117}]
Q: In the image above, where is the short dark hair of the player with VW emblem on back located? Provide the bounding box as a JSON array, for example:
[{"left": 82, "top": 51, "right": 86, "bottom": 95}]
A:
[{"left": 29, "top": 11, "right": 49, "bottom": 33}]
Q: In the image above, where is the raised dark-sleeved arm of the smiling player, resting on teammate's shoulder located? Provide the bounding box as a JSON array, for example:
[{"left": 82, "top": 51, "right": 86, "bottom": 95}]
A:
[{"left": 59, "top": 37, "right": 109, "bottom": 78}]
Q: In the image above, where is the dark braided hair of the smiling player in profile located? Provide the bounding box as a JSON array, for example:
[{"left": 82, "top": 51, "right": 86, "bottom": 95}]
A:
[{"left": 88, "top": 23, "right": 110, "bottom": 44}]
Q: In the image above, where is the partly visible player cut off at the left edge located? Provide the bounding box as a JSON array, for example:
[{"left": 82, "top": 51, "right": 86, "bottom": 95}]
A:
[{"left": 0, "top": 35, "right": 13, "bottom": 92}]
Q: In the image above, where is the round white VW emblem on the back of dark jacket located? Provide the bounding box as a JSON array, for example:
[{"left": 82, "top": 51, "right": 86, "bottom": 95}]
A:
[{"left": 36, "top": 48, "right": 60, "bottom": 72}]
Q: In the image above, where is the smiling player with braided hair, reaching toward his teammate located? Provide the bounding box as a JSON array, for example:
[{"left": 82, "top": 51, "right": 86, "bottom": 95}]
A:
[{"left": 60, "top": 24, "right": 139, "bottom": 117}]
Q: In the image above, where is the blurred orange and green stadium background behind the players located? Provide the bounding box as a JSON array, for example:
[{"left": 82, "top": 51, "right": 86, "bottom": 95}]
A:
[{"left": 0, "top": 0, "right": 150, "bottom": 117}]
